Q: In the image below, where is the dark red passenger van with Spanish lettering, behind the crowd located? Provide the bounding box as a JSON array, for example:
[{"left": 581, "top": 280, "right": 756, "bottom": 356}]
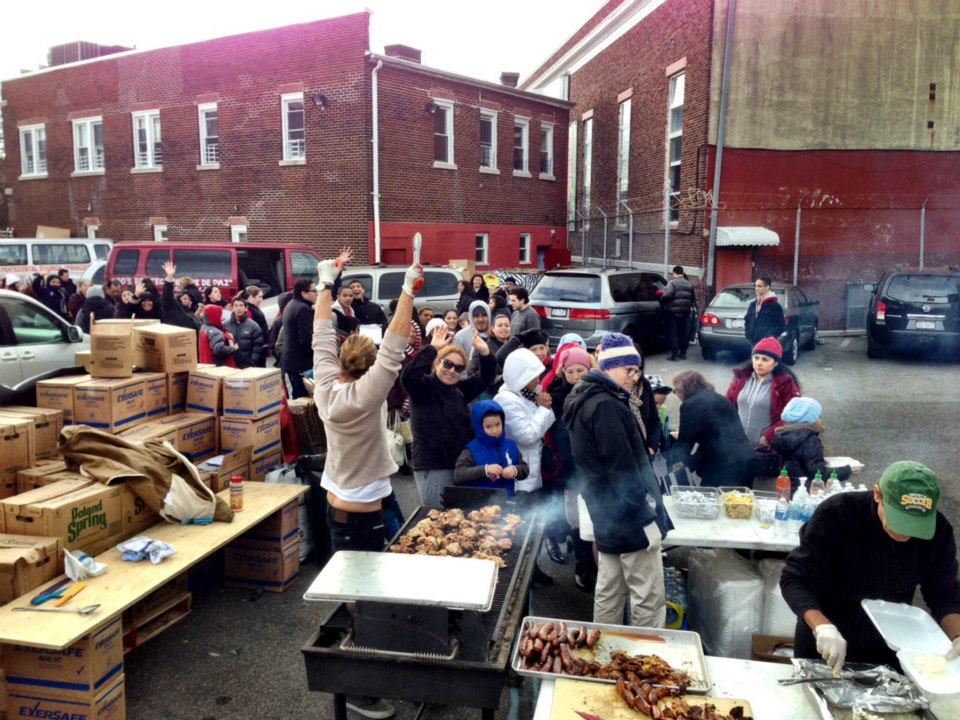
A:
[{"left": 104, "top": 242, "right": 320, "bottom": 300}]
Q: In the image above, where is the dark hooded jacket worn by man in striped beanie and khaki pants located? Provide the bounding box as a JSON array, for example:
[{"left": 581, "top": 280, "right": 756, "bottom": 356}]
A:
[{"left": 563, "top": 370, "right": 673, "bottom": 555}]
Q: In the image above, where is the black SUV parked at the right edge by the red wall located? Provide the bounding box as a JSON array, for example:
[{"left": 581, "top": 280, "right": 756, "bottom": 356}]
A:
[{"left": 867, "top": 267, "right": 960, "bottom": 358}]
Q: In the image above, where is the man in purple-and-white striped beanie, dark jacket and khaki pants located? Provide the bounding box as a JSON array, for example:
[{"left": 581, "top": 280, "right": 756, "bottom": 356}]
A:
[{"left": 563, "top": 333, "right": 673, "bottom": 627}]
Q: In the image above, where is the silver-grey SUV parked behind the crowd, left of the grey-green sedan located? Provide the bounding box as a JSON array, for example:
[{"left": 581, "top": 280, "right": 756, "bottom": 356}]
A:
[{"left": 530, "top": 266, "right": 695, "bottom": 352}]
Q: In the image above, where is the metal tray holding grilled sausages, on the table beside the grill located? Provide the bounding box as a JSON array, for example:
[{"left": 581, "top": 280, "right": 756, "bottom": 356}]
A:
[{"left": 510, "top": 616, "right": 713, "bottom": 694}]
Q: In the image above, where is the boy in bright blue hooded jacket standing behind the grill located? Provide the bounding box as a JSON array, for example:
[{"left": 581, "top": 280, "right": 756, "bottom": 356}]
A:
[{"left": 453, "top": 400, "right": 530, "bottom": 497}]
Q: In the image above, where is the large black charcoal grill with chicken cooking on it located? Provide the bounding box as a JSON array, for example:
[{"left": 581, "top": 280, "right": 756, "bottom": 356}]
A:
[{"left": 302, "top": 488, "right": 542, "bottom": 720}]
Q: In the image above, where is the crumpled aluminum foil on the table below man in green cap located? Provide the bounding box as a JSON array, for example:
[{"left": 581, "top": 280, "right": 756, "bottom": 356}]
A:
[{"left": 793, "top": 659, "right": 930, "bottom": 714}]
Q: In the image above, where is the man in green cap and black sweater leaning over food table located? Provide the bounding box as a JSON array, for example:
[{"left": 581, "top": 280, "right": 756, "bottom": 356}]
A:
[{"left": 780, "top": 460, "right": 960, "bottom": 674}]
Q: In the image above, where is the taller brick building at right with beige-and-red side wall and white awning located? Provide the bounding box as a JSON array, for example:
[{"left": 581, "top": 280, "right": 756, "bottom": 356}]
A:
[{"left": 521, "top": 0, "right": 960, "bottom": 329}]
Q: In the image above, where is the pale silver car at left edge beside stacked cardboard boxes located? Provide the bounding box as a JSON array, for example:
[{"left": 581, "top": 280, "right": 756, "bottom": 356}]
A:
[{"left": 0, "top": 290, "right": 90, "bottom": 404}]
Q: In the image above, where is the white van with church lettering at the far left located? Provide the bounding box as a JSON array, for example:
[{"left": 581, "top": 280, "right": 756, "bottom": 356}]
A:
[{"left": 0, "top": 238, "right": 113, "bottom": 279}]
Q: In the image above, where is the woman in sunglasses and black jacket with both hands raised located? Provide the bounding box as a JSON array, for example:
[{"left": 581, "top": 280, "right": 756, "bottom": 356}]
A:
[{"left": 400, "top": 327, "right": 497, "bottom": 507}]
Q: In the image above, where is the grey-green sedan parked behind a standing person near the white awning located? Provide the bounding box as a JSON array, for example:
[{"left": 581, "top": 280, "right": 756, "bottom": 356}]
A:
[{"left": 699, "top": 283, "right": 820, "bottom": 365}]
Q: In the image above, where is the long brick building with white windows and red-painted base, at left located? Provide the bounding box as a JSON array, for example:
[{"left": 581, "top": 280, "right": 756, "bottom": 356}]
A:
[{"left": 3, "top": 13, "right": 569, "bottom": 267}]
